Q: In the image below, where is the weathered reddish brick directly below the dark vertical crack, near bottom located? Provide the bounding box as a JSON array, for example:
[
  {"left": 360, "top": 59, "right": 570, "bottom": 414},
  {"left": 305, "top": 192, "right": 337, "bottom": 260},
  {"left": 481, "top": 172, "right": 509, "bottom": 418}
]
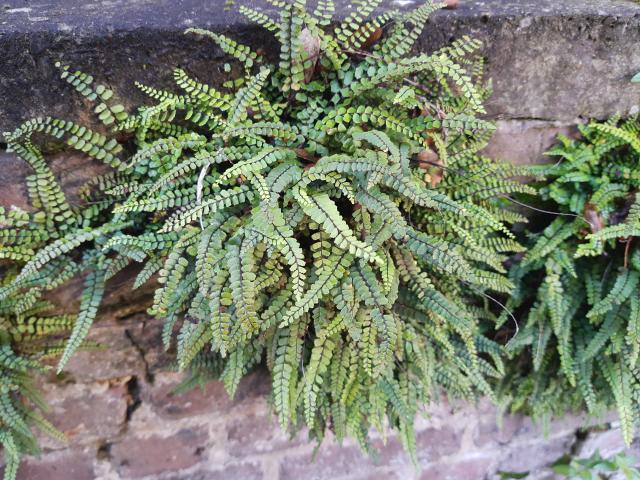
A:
[{"left": 110, "top": 428, "right": 208, "bottom": 478}]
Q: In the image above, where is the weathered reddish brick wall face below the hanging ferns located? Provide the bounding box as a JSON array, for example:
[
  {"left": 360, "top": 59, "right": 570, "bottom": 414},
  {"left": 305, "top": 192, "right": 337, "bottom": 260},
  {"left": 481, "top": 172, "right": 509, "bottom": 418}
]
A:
[{"left": 6, "top": 314, "right": 636, "bottom": 480}]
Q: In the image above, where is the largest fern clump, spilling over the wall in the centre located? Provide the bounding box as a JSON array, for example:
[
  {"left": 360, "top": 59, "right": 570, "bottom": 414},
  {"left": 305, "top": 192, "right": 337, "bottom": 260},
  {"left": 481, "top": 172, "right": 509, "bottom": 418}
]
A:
[{"left": 0, "top": 0, "right": 531, "bottom": 472}]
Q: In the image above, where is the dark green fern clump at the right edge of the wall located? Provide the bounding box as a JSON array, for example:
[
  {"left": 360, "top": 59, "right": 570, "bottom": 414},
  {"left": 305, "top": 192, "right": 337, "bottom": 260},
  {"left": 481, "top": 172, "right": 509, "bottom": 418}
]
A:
[{"left": 501, "top": 117, "right": 640, "bottom": 443}]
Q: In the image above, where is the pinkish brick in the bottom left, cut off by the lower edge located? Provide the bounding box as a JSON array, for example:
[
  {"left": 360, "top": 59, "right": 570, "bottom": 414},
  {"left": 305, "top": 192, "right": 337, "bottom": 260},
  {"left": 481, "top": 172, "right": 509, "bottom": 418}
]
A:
[{"left": 18, "top": 449, "right": 95, "bottom": 480}]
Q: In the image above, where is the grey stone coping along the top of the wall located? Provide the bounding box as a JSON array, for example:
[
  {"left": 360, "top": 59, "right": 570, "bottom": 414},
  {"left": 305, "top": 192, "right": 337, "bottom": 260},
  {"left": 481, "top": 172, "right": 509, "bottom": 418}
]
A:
[{"left": 0, "top": 0, "right": 640, "bottom": 131}]
